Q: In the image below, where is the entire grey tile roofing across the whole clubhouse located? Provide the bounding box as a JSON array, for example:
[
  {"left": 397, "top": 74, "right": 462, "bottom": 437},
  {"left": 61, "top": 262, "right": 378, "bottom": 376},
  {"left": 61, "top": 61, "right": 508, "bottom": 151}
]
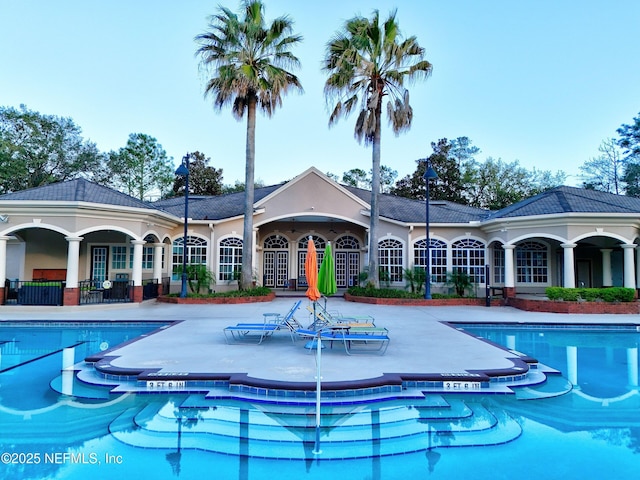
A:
[{"left": 0, "top": 178, "right": 640, "bottom": 224}]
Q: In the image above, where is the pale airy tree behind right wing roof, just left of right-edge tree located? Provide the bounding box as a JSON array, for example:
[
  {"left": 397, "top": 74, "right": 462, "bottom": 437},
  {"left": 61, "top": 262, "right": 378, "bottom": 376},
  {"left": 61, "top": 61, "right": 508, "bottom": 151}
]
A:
[{"left": 580, "top": 138, "right": 627, "bottom": 194}]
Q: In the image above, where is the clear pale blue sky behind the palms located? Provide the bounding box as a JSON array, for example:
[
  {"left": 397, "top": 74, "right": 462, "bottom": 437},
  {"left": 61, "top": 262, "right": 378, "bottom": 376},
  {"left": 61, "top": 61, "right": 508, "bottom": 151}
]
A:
[{"left": 0, "top": 0, "right": 640, "bottom": 185}]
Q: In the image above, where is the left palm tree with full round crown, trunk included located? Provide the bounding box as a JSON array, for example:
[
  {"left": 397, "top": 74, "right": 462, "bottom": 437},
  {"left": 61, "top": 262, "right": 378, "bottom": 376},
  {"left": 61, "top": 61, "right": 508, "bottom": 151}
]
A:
[{"left": 195, "top": 0, "right": 302, "bottom": 288}]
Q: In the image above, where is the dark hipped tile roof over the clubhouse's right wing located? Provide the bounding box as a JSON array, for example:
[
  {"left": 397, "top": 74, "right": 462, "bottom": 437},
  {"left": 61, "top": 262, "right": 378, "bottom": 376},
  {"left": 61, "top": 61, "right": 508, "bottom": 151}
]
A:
[{"left": 489, "top": 186, "right": 640, "bottom": 219}]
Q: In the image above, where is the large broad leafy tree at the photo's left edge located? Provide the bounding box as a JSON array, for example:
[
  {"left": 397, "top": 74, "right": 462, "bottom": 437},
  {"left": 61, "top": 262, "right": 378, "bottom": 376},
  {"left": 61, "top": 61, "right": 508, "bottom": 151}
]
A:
[{"left": 0, "top": 105, "right": 102, "bottom": 193}]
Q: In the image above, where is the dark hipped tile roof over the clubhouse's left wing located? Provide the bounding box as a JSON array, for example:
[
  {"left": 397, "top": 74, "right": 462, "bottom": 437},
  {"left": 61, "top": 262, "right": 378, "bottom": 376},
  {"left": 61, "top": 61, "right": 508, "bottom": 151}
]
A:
[{"left": 0, "top": 178, "right": 155, "bottom": 209}]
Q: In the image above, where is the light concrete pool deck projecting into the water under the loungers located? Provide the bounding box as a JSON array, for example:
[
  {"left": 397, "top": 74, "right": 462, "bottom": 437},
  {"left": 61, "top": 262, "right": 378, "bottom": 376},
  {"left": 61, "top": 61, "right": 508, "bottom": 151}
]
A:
[{"left": 0, "top": 297, "right": 640, "bottom": 388}]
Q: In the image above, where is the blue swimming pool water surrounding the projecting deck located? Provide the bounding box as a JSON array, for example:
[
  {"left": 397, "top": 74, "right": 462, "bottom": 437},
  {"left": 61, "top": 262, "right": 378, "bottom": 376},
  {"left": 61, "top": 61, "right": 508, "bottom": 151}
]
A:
[{"left": 0, "top": 324, "right": 640, "bottom": 480}]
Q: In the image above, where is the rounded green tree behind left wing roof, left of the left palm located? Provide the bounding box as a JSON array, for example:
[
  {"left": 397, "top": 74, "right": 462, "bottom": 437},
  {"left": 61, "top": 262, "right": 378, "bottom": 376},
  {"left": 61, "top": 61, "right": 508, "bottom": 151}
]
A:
[{"left": 100, "top": 133, "right": 174, "bottom": 200}]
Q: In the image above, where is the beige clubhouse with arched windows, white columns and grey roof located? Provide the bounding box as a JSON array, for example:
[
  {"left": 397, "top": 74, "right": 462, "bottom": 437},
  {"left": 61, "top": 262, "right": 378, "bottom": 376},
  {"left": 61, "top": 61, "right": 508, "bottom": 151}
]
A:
[{"left": 0, "top": 167, "right": 640, "bottom": 305}]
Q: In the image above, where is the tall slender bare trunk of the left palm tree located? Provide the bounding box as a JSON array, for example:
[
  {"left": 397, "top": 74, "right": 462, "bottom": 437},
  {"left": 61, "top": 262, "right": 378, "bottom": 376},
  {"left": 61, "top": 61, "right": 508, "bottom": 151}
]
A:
[{"left": 240, "top": 96, "right": 256, "bottom": 290}]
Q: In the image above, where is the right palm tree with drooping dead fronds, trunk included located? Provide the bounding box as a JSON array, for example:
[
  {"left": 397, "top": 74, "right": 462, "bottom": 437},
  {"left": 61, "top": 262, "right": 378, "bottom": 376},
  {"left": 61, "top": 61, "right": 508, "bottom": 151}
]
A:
[{"left": 324, "top": 10, "right": 432, "bottom": 286}]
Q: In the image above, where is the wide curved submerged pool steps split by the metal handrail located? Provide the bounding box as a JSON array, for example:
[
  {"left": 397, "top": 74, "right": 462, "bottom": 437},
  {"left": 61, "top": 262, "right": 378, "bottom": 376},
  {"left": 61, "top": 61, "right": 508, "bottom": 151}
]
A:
[{"left": 109, "top": 398, "right": 521, "bottom": 459}]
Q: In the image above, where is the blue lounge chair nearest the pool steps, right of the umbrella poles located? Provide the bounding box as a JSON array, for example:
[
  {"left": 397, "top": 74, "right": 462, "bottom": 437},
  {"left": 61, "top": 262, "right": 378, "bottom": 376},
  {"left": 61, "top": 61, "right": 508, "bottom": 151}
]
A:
[{"left": 296, "top": 327, "right": 391, "bottom": 355}]
